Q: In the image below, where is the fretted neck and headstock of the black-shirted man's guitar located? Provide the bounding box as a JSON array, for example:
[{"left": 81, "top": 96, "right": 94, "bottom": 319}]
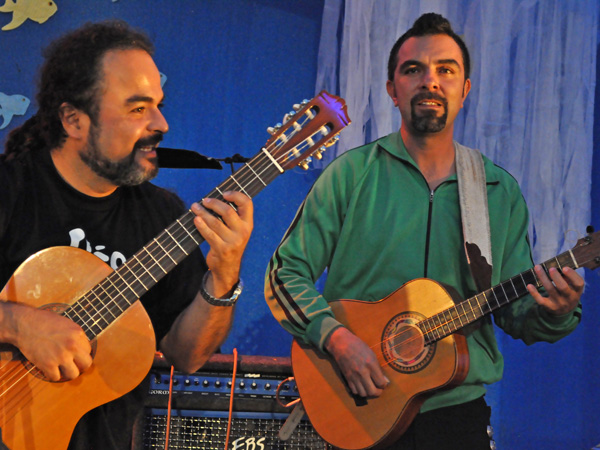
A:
[{"left": 58, "top": 91, "right": 350, "bottom": 340}]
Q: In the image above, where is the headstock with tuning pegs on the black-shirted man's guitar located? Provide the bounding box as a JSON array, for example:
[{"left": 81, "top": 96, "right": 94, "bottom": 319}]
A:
[{"left": 263, "top": 91, "right": 350, "bottom": 170}]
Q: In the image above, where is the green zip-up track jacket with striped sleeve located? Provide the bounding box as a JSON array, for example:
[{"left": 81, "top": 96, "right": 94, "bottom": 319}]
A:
[{"left": 265, "top": 133, "right": 581, "bottom": 412}]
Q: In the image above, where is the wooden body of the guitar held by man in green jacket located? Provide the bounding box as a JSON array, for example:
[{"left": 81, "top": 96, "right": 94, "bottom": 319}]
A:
[{"left": 291, "top": 279, "right": 469, "bottom": 449}]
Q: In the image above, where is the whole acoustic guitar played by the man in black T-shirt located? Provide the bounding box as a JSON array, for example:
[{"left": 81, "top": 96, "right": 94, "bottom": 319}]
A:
[{"left": 0, "top": 91, "right": 350, "bottom": 450}]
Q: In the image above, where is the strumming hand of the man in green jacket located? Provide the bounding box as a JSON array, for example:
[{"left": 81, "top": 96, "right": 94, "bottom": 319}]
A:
[{"left": 325, "top": 327, "right": 390, "bottom": 397}]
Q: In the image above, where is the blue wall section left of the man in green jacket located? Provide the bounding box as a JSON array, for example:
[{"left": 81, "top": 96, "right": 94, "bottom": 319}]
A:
[{"left": 0, "top": 0, "right": 323, "bottom": 356}]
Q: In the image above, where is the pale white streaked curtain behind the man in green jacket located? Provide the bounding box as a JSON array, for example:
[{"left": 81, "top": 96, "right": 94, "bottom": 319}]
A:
[{"left": 316, "top": 0, "right": 598, "bottom": 262}]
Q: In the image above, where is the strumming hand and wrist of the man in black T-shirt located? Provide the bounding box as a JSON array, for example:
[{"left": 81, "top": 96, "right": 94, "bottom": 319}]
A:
[{"left": 0, "top": 302, "right": 92, "bottom": 381}]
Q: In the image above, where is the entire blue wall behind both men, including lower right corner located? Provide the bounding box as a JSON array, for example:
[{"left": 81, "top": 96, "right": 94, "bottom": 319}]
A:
[{"left": 0, "top": 0, "right": 600, "bottom": 449}]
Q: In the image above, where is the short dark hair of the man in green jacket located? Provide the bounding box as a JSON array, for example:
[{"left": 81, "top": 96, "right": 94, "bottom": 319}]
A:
[{"left": 388, "top": 13, "right": 471, "bottom": 81}]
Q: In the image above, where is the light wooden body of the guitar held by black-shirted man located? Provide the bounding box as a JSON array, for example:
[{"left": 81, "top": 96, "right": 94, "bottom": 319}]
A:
[{"left": 0, "top": 247, "right": 156, "bottom": 450}]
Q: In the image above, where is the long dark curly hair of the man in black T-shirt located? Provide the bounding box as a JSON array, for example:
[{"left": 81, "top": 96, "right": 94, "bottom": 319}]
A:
[{"left": 4, "top": 20, "right": 154, "bottom": 157}]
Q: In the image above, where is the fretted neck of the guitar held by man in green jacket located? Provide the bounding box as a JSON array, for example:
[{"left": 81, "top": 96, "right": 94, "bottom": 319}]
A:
[{"left": 418, "top": 250, "right": 580, "bottom": 344}]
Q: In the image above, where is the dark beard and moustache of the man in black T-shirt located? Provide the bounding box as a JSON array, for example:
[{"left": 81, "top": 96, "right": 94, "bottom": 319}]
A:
[{"left": 79, "top": 125, "right": 163, "bottom": 186}]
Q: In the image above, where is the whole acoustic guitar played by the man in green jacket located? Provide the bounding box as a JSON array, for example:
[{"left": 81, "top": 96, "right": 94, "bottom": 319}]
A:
[{"left": 291, "top": 231, "right": 600, "bottom": 450}]
